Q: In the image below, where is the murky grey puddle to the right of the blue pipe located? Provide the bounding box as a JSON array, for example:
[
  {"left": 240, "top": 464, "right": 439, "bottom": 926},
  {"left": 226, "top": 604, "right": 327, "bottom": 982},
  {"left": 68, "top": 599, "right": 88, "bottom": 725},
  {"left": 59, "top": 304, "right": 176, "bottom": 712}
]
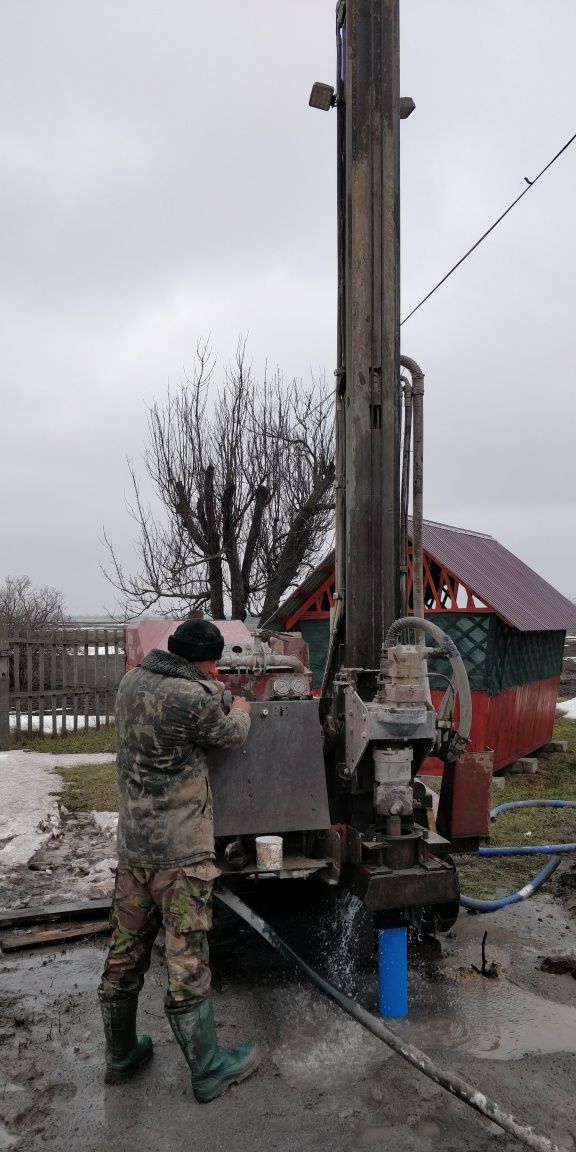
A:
[{"left": 393, "top": 973, "right": 576, "bottom": 1060}]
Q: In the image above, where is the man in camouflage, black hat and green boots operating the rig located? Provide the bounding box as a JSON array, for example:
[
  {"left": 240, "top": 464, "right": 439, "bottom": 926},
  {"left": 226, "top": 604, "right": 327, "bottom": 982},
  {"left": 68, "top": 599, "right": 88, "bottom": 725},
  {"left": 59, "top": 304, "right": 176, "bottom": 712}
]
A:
[{"left": 98, "top": 620, "right": 259, "bottom": 1102}]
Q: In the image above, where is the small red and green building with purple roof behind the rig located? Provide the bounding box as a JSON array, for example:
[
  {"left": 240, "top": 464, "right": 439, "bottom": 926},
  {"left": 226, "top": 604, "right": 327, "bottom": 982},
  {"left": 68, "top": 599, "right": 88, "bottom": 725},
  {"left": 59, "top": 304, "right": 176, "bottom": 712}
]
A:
[{"left": 266, "top": 521, "right": 576, "bottom": 770}]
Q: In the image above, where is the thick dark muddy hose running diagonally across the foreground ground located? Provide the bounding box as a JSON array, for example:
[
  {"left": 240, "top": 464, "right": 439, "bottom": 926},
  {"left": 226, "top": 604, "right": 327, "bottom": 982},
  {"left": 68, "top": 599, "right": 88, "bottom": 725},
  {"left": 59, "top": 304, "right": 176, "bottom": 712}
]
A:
[{"left": 214, "top": 888, "right": 561, "bottom": 1152}]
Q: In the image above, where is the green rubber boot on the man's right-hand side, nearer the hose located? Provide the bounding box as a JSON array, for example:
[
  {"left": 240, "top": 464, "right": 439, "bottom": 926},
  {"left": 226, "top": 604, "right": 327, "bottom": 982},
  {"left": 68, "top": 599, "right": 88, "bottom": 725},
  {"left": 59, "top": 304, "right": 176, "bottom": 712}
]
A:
[{"left": 166, "top": 999, "right": 260, "bottom": 1104}]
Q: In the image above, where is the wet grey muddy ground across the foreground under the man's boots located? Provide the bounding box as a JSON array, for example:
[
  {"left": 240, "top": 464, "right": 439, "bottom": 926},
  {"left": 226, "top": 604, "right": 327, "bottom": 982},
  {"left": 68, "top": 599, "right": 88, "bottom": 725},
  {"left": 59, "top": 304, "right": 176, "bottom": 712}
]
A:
[{"left": 0, "top": 881, "right": 576, "bottom": 1152}]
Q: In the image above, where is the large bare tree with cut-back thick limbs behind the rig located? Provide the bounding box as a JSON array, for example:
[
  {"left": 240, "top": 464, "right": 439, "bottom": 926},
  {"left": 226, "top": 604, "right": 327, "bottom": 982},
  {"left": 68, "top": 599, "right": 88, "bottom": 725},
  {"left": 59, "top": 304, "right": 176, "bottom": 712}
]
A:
[{"left": 104, "top": 341, "right": 334, "bottom": 621}]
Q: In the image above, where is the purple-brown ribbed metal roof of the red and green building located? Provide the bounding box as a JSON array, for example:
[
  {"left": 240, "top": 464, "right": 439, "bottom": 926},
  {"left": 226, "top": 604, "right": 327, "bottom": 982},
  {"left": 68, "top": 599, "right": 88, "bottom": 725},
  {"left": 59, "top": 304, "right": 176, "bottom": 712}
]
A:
[{"left": 266, "top": 520, "right": 576, "bottom": 632}]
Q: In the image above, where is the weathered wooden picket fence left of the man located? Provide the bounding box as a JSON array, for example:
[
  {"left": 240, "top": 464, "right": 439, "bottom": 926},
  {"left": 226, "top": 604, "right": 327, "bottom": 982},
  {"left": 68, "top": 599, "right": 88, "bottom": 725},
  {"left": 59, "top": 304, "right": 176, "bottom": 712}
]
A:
[{"left": 0, "top": 628, "right": 126, "bottom": 746}]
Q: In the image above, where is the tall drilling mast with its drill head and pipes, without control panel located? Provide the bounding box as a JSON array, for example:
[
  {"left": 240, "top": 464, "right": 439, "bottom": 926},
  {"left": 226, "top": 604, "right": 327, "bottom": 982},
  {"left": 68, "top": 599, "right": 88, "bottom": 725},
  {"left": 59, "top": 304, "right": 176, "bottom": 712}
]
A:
[{"left": 310, "top": 0, "right": 490, "bottom": 919}]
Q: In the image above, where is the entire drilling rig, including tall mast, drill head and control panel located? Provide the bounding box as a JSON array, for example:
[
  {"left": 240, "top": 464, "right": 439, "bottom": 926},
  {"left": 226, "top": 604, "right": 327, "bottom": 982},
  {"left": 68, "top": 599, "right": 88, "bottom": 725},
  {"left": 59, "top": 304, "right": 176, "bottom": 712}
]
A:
[{"left": 128, "top": 0, "right": 492, "bottom": 926}]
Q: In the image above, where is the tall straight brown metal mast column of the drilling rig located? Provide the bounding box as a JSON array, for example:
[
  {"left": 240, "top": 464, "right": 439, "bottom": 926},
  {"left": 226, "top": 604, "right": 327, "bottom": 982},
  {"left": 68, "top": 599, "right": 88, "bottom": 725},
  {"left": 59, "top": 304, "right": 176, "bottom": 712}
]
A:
[{"left": 336, "top": 0, "right": 400, "bottom": 668}]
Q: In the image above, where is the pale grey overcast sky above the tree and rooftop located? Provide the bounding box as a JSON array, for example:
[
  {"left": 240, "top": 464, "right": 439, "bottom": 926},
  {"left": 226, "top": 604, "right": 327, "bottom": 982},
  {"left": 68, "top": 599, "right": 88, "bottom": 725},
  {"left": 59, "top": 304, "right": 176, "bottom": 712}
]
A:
[{"left": 0, "top": 0, "right": 576, "bottom": 614}]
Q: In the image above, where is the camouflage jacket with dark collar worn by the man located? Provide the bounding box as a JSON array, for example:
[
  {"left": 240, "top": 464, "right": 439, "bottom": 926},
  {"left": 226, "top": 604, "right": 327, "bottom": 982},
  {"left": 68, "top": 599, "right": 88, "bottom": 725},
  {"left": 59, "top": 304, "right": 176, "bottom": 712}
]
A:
[{"left": 116, "top": 649, "right": 250, "bottom": 867}]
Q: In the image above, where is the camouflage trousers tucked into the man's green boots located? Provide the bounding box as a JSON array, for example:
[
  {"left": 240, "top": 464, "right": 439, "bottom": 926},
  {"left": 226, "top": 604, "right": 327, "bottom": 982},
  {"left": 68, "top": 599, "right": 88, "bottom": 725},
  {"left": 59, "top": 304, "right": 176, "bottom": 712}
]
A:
[{"left": 98, "top": 861, "right": 219, "bottom": 1010}]
